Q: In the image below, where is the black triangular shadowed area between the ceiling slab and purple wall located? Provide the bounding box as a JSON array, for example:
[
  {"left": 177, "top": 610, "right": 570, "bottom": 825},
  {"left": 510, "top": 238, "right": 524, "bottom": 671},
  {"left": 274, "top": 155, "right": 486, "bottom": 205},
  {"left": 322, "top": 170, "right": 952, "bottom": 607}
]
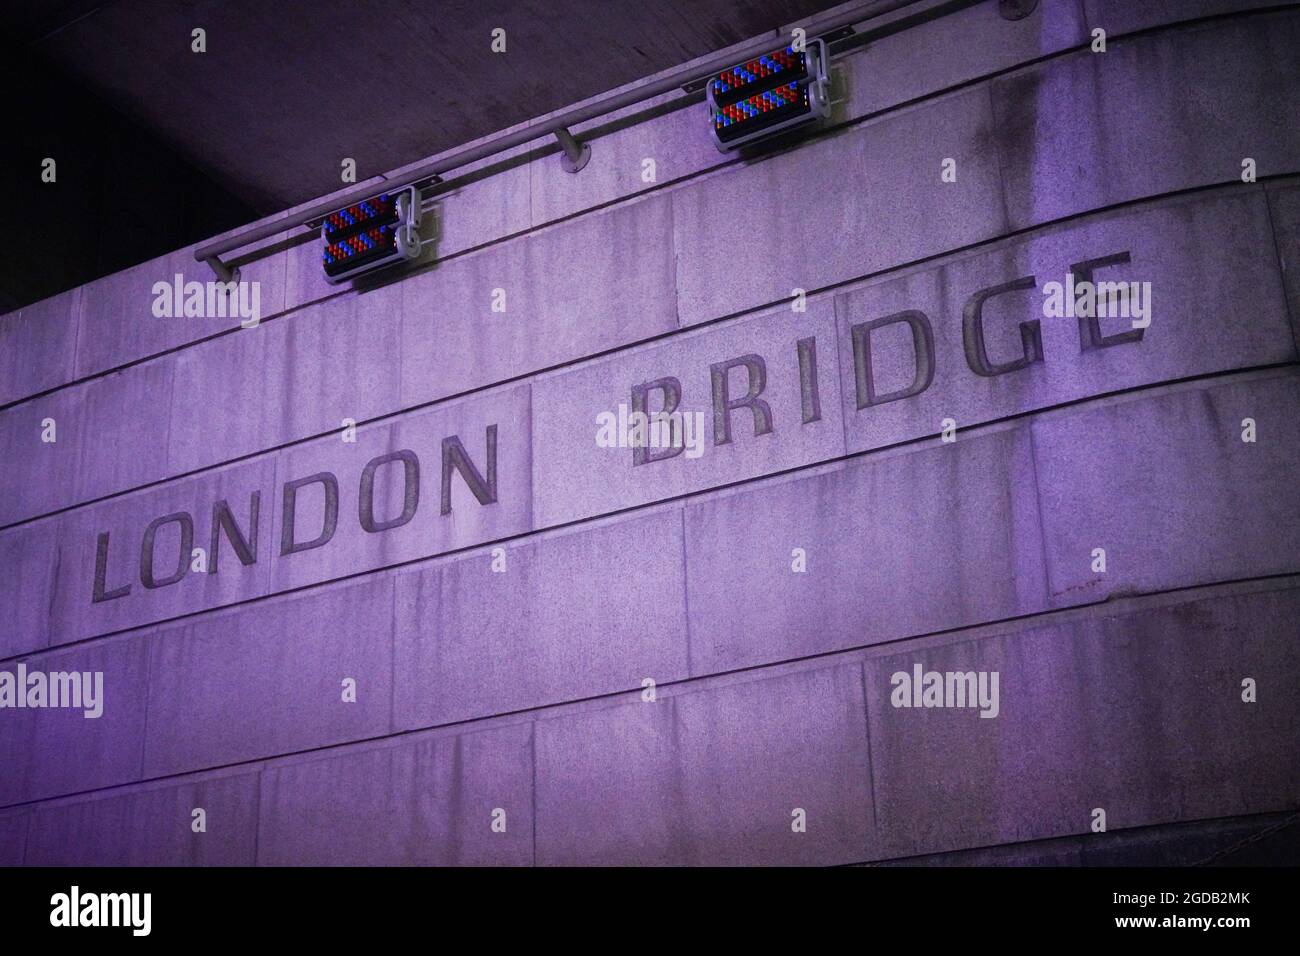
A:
[{"left": 0, "top": 46, "right": 265, "bottom": 312}]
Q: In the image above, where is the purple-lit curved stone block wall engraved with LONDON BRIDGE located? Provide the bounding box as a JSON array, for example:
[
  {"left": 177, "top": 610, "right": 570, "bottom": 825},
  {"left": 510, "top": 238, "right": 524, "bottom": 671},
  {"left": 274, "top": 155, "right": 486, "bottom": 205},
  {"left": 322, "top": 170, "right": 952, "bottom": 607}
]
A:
[{"left": 0, "top": 0, "right": 1300, "bottom": 864}]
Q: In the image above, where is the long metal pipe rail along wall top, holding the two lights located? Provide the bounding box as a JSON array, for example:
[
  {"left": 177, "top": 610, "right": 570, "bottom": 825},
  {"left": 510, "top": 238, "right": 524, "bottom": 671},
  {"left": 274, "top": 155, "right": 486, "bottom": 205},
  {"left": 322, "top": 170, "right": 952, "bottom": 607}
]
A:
[{"left": 194, "top": 0, "right": 918, "bottom": 282}]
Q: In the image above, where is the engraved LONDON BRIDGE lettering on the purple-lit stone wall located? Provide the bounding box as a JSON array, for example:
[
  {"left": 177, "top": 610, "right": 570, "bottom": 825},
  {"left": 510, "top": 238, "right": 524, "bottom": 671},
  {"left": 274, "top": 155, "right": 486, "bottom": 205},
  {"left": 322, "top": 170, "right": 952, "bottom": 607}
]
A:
[{"left": 91, "top": 252, "right": 1144, "bottom": 604}]
